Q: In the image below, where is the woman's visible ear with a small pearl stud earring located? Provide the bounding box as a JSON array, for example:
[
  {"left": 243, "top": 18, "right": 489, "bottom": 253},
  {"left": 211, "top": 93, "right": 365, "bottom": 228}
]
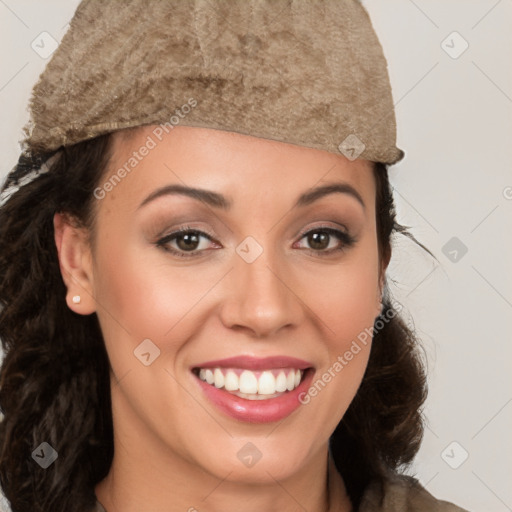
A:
[{"left": 53, "top": 213, "right": 96, "bottom": 315}]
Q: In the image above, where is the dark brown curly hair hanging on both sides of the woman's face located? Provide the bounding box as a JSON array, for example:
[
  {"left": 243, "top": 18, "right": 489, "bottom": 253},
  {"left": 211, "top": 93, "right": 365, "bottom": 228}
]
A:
[{"left": 0, "top": 134, "right": 427, "bottom": 512}]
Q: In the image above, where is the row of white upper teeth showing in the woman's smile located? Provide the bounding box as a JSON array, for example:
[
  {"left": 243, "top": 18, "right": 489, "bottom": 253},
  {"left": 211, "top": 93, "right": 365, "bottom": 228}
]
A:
[{"left": 199, "top": 368, "right": 304, "bottom": 400}]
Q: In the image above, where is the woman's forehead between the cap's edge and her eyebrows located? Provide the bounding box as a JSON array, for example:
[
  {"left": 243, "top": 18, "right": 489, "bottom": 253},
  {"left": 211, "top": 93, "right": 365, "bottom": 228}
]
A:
[{"left": 106, "top": 125, "right": 375, "bottom": 210}]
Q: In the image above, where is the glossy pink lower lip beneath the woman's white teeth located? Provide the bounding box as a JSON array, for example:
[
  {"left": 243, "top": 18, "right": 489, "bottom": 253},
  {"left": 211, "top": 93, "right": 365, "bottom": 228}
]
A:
[{"left": 194, "top": 368, "right": 314, "bottom": 423}]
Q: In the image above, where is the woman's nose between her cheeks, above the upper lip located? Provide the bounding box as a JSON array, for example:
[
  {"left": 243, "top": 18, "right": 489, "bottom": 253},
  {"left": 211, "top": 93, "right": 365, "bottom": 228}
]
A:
[{"left": 221, "top": 245, "right": 304, "bottom": 338}]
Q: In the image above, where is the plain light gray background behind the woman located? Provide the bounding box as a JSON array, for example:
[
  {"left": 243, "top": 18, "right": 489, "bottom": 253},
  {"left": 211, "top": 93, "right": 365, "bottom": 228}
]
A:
[{"left": 0, "top": 0, "right": 512, "bottom": 512}]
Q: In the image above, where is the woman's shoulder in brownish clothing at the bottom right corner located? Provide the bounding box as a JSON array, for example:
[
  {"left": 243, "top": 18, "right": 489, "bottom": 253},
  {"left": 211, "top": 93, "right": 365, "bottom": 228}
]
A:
[{"left": 359, "top": 474, "right": 468, "bottom": 512}]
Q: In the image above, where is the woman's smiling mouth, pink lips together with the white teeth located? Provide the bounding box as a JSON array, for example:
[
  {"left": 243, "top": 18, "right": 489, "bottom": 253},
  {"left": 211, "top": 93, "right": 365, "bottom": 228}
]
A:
[{"left": 191, "top": 356, "right": 315, "bottom": 423}]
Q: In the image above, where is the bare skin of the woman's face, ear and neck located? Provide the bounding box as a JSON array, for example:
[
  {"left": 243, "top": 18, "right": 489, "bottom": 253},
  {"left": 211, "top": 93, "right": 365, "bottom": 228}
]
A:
[{"left": 54, "top": 126, "right": 387, "bottom": 512}]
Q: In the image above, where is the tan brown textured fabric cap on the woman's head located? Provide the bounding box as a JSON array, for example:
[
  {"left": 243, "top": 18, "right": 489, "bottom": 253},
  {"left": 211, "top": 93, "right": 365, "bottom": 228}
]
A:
[{"left": 23, "top": 0, "right": 404, "bottom": 164}]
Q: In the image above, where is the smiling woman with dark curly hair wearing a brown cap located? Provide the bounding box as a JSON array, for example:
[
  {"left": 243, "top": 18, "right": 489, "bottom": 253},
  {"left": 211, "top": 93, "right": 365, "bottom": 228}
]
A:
[{"left": 0, "top": 0, "right": 470, "bottom": 512}]
